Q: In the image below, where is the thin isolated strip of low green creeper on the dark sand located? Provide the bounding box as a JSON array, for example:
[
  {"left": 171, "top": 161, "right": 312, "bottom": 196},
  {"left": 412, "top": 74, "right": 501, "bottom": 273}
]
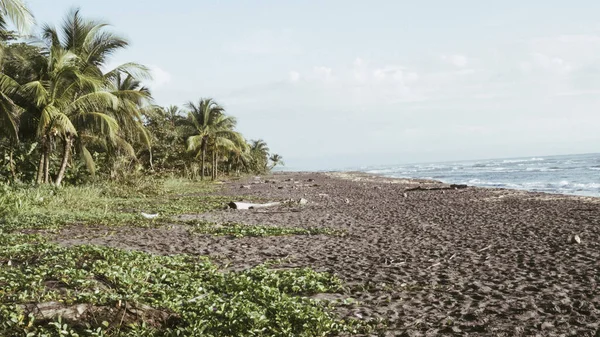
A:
[{"left": 188, "top": 222, "right": 344, "bottom": 238}]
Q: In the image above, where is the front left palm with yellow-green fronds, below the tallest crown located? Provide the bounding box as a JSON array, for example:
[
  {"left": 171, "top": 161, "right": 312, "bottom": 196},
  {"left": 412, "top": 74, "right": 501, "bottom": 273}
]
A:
[{"left": 15, "top": 46, "right": 119, "bottom": 185}]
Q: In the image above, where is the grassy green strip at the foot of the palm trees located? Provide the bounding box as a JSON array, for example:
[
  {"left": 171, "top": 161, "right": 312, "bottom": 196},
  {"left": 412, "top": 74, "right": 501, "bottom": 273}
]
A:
[{"left": 0, "top": 178, "right": 229, "bottom": 231}]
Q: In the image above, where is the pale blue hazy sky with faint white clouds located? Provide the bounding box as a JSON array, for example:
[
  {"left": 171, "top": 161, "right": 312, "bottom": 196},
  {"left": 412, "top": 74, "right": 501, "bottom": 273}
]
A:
[{"left": 27, "top": 0, "right": 600, "bottom": 170}]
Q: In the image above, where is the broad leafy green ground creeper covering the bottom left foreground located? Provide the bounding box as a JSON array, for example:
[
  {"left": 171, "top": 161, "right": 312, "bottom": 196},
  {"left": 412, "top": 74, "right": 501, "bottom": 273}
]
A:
[{"left": 0, "top": 234, "right": 368, "bottom": 336}]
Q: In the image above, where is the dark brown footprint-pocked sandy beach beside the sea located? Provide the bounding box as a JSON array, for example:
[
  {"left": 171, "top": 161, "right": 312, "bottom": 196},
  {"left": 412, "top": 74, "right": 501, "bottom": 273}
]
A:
[{"left": 56, "top": 173, "right": 600, "bottom": 336}]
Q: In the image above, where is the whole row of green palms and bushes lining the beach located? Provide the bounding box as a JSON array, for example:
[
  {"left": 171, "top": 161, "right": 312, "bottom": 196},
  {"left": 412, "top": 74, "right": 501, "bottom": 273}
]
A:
[{"left": 0, "top": 4, "right": 283, "bottom": 185}]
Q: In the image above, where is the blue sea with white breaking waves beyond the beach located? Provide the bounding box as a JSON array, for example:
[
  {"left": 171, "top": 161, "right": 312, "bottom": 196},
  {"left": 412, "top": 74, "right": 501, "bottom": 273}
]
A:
[{"left": 362, "top": 153, "right": 600, "bottom": 197}]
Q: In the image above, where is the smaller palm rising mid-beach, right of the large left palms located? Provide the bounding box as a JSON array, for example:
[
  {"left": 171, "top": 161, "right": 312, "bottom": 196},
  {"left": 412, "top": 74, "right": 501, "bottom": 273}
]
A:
[{"left": 186, "top": 98, "right": 243, "bottom": 180}]
